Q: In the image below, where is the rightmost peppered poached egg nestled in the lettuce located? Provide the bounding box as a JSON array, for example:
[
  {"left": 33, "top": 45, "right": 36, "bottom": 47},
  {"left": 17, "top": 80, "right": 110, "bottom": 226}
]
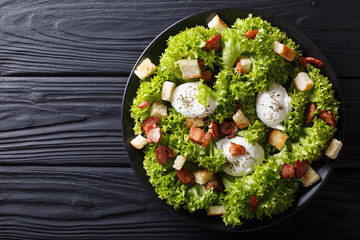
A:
[{"left": 256, "top": 83, "right": 291, "bottom": 130}]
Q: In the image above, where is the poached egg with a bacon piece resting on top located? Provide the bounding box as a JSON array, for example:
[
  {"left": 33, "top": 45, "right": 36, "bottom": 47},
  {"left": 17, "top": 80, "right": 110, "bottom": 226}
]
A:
[{"left": 216, "top": 137, "right": 265, "bottom": 177}]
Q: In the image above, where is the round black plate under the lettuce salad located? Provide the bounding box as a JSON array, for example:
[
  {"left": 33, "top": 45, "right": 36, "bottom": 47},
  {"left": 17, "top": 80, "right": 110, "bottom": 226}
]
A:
[{"left": 122, "top": 9, "right": 345, "bottom": 232}]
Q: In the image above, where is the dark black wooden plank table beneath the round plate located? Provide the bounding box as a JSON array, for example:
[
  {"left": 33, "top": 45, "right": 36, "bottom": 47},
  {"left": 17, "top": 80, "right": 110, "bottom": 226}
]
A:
[{"left": 0, "top": 0, "right": 360, "bottom": 239}]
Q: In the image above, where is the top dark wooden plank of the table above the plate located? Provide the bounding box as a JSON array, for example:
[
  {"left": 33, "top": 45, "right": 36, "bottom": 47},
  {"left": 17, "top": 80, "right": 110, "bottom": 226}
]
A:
[{"left": 0, "top": 0, "right": 360, "bottom": 78}]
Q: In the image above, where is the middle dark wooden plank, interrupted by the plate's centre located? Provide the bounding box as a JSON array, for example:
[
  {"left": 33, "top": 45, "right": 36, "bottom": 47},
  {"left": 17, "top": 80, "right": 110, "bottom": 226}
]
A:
[{"left": 0, "top": 77, "right": 360, "bottom": 168}]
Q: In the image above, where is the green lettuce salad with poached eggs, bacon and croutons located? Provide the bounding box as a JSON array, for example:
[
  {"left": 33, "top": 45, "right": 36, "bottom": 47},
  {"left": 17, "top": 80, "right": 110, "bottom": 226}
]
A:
[{"left": 131, "top": 15, "right": 342, "bottom": 226}]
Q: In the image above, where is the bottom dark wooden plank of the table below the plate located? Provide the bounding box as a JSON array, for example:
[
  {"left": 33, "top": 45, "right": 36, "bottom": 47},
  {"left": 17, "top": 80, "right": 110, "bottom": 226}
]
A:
[{"left": 0, "top": 166, "right": 360, "bottom": 239}]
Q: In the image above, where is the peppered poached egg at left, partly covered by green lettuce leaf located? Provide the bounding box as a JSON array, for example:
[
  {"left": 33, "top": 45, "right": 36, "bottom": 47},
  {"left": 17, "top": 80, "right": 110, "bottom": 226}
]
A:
[{"left": 171, "top": 82, "right": 217, "bottom": 118}]
